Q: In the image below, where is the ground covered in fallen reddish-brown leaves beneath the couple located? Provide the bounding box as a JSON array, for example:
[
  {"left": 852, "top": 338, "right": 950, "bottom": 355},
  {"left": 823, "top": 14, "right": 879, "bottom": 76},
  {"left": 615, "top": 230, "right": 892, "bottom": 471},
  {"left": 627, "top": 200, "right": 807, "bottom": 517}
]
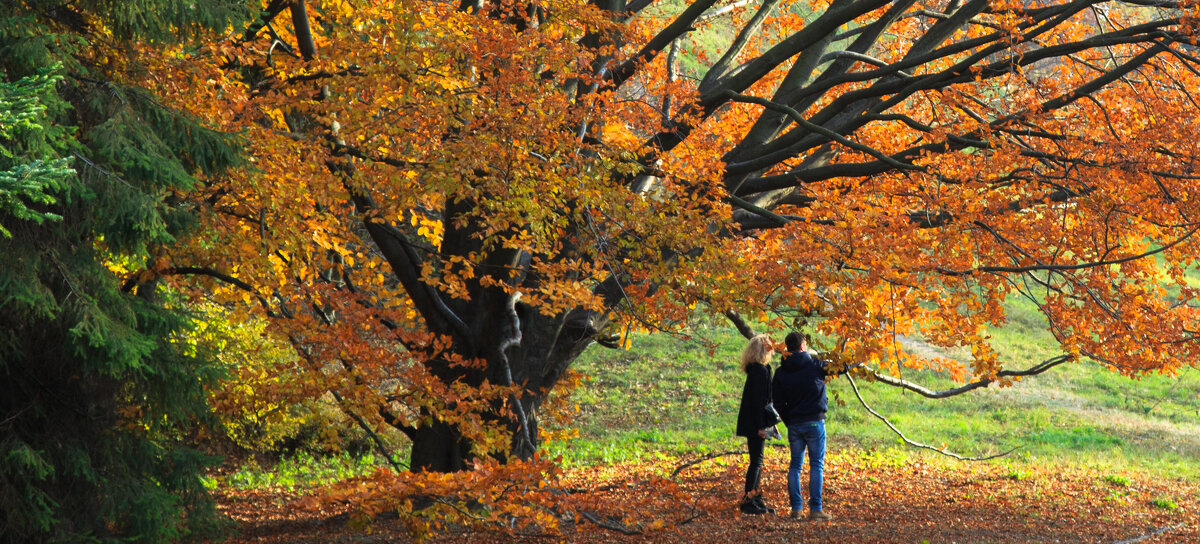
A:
[{"left": 217, "top": 450, "right": 1200, "bottom": 544}]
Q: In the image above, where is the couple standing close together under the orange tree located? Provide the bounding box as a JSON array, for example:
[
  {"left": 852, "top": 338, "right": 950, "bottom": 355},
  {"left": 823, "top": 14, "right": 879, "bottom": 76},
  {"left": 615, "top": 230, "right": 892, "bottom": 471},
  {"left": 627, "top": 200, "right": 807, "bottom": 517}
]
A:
[{"left": 737, "top": 331, "right": 833, "bottom": 520}]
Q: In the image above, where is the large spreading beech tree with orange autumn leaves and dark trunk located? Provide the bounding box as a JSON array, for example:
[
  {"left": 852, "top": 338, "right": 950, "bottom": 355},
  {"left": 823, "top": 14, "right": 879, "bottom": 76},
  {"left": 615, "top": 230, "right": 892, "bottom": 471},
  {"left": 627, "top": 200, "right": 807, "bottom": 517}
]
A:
[{"left": 148, "top": 0, "right": 1200, "bottom": 471}]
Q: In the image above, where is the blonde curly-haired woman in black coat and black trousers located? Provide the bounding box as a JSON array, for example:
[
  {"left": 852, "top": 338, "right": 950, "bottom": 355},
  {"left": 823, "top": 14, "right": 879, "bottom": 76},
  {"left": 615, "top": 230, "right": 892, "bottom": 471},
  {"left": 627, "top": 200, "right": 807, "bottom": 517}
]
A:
[{"left": 737, "top": 334, "right": 775, "bottom": 514}]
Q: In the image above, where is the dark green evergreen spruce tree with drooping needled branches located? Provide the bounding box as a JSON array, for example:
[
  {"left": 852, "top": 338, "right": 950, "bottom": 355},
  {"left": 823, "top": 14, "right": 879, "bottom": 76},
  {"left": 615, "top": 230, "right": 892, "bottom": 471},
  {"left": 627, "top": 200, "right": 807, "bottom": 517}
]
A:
[{"left": 0, "top": 0, "right": 245, "bottom": 543}]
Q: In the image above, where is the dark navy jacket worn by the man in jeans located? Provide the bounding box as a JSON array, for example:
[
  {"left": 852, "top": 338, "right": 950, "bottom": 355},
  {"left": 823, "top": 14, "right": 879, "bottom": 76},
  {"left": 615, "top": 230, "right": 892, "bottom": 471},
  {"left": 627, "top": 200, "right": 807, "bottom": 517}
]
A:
[{"left": 770, "top": 352, "right": 829, "bottom": 425}]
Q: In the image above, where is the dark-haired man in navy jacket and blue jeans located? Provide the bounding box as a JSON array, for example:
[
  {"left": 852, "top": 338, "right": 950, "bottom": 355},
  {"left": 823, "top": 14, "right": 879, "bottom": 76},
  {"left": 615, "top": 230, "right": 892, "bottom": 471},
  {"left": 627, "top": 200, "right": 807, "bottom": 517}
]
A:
[{"left": 770, "top": 331, "right": 833, "bottom": 521}]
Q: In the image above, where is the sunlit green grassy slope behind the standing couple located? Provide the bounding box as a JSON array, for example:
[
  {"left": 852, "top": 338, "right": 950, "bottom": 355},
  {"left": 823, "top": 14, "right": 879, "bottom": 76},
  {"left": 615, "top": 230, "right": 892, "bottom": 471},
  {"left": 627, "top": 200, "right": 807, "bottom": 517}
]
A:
[{"left": 548, "top": 296, "right": 1200, "bottom": 479}]
